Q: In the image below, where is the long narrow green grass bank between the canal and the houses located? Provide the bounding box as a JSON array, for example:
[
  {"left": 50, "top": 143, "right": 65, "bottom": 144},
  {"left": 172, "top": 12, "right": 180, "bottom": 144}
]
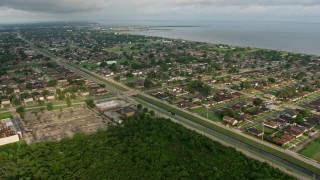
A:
[{"left": 137, "top": 95, "right": 320, "bottom": 174}]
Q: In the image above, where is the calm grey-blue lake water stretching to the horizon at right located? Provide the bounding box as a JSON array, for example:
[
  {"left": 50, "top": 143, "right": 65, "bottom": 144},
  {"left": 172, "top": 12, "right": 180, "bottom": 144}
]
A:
[{"left": 109, "top": 21, "right": 320, "bottom": 55}]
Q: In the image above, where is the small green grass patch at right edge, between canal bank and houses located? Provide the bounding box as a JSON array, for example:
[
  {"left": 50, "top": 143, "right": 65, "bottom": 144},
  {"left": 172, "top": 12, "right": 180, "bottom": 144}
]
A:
[{"left": 300, "top": 138, "right": 320, "bottom": 162}]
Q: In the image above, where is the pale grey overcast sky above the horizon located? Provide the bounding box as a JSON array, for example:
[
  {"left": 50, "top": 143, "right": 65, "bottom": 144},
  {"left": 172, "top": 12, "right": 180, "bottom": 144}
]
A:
[{"left": 0, "top": 0, "right": 320, "bottom": 23}]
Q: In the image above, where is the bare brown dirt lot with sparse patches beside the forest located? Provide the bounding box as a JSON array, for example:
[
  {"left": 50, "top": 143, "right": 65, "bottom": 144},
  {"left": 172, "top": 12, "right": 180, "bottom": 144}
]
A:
[{"left": 23, "top": 107, "right": 107, "bottom": 144}]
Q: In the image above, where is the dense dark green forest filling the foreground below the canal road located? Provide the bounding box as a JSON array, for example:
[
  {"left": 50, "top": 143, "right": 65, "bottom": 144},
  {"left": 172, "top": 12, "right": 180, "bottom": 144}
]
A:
[{"left": 0, "top": 113, "right": 294, "bottom": 179}]
